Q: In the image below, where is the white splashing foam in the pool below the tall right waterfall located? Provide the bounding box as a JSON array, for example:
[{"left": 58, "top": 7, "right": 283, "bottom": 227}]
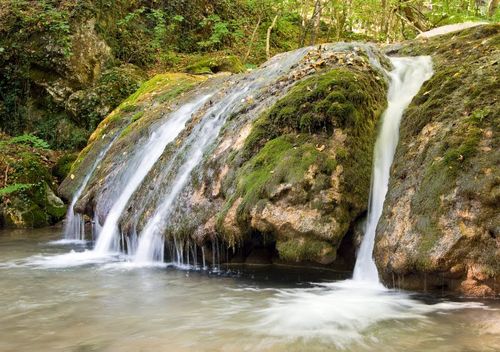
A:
[{"left": 256, "top": 280, "right": 488, "bottom": 348}]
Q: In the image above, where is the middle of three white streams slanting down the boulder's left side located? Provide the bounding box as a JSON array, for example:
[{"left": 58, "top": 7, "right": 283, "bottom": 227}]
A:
[{"left": 94, "top": 95, "right": 211, "bottom": 255}]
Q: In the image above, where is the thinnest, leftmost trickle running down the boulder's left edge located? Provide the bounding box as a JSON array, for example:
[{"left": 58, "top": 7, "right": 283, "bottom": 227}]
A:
[{"left": 64, "top": 136, "right": 116, "bottom": 241}]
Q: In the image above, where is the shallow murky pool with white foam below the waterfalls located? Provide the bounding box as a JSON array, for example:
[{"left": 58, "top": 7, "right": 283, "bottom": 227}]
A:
[{"left": 0, "top": 228, "right": 500, "bottom": 352}]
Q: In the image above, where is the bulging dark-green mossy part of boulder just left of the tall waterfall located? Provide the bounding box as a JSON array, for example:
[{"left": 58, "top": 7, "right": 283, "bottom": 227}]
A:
[{"left": 217, "top": 62, "right": 387, "bottom": 264}]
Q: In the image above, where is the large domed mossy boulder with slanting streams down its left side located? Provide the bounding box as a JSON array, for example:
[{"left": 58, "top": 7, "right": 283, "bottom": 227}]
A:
[{"left": 65, "top": 44, "right": 389, "bottom": 268}]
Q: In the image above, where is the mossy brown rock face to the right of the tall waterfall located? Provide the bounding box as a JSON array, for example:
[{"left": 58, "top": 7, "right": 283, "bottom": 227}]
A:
[{"left": 375, "top": 25, "right": 500, "bottom": 296}]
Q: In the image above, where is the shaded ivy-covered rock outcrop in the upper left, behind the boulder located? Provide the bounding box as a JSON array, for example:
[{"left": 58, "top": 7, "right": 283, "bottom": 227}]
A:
[{"left": 0, "top": 1, "right": 145, "bottom": 150}]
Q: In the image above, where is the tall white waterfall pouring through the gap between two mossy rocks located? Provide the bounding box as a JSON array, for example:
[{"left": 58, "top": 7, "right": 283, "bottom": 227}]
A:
[{"left": 353, "top": 56, "right": 433, "bottom": 284}]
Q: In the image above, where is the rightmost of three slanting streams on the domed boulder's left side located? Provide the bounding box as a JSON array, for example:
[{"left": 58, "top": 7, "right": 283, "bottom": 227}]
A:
[{"left": 134, "top": 49, "right": 305, "bottom": 263}]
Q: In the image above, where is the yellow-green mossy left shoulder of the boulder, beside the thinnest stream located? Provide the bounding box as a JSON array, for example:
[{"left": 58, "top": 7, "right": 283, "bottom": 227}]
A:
[{"left": 58, "top": 73, "right": 206, "bottom": 207}]
